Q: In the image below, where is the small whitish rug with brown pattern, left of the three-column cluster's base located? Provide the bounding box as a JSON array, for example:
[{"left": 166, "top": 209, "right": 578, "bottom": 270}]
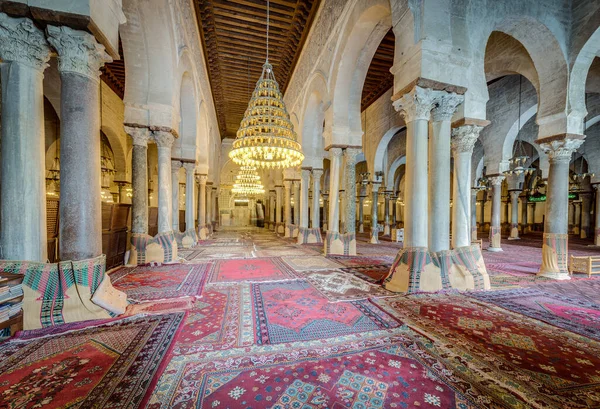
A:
[{"left": 306, "top": 271, "right": 395, "bottom": 302}]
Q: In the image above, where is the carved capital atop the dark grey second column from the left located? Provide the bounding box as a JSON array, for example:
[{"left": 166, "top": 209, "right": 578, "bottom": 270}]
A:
[{"left": 46, "top": 26, "right": 112, "bottom": 81}]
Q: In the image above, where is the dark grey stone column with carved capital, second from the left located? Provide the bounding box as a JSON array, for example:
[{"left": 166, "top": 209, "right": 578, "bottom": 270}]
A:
[{"left": 47, "top": 26, "right": 111, "bottom": 260}]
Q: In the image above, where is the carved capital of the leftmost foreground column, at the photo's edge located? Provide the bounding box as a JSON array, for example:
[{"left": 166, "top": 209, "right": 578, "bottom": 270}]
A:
[{"left": 0, "top": 13, "right": 50, "bottom": 72}]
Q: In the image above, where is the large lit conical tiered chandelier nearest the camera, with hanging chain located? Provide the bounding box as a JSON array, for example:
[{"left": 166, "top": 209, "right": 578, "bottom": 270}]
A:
[{"left": 229, "top": 0, "right": 304, "bottom": 169}]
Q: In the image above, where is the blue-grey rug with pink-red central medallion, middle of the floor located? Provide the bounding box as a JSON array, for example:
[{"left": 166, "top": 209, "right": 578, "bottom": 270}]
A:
[{"left": 252, "top": 280, "right": 399, "bottom": 345}]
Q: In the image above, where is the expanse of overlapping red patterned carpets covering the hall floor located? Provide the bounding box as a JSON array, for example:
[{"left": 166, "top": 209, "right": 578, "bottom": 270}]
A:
[{"left": 0, "top": 229, "right": 600, "bottom": 409}]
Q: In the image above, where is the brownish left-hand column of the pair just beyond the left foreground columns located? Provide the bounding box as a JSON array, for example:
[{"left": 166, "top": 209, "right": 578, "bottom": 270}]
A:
[{"left": 125, "top": 126, "right": 150, "bottom": 234}]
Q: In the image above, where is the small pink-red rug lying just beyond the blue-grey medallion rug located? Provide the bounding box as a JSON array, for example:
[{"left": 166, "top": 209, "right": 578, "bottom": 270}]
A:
[{"left": 209, "top": 257, "right": 297, "bottom": 283}]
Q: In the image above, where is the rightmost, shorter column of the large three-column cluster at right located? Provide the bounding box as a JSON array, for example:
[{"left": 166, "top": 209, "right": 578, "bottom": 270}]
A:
[{"left": 452, "top": 125, "right": 480, "bottom": 248}]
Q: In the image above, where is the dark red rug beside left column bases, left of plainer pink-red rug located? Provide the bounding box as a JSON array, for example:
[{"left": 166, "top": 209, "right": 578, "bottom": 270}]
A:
[{"left": 110, "top": 264, "right": 208, "bottom": 302}]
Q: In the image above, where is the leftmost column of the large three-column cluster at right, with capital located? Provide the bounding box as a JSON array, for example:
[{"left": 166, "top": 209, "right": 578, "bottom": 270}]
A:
[{"left": 394, "top": 87, "right": 434, "bottom": 248}]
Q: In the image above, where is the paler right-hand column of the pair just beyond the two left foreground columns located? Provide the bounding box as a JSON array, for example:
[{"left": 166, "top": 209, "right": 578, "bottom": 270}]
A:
[{"left": 152, "top": 131, "right": 175, "bottom": 233}]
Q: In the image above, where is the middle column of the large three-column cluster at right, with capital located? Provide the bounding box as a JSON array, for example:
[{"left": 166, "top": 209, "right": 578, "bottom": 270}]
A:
[{"left": 428, "top": 93, "right": 464, "bottom": 252}]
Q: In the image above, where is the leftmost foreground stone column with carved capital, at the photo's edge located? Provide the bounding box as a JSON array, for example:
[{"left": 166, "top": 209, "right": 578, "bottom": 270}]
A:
[{"left": 0, "top": 13, "right": 51, "bottom": 263}]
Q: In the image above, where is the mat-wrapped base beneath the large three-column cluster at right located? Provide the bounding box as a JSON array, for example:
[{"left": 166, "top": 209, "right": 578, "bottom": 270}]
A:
[{"left": 383, "top": 246, "right": 491, "bottom": 293}]
